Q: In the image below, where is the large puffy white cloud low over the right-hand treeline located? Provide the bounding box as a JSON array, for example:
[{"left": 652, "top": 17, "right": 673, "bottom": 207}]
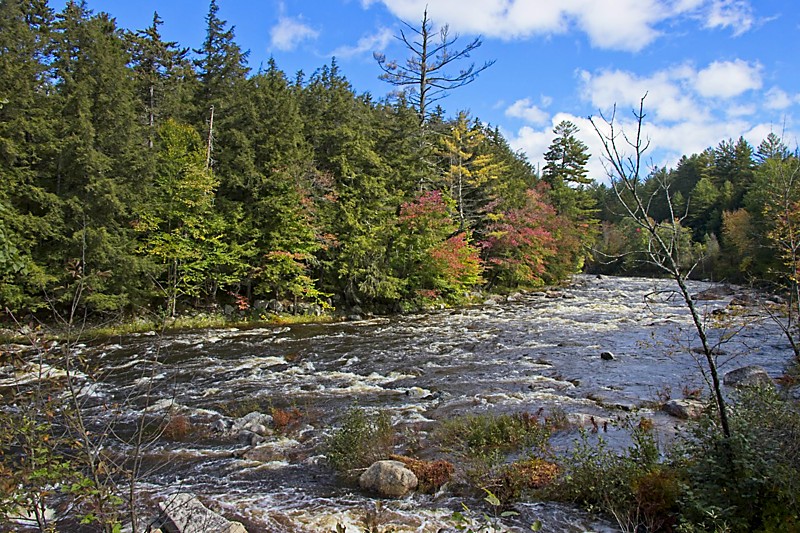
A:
[{"left": 507, "top": 60, "right": 800, "bottom": 182}]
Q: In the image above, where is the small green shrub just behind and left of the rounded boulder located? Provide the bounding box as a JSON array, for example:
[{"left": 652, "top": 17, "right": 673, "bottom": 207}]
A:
[{"left": 325, "top": 407, "right": 395, "bottom": 478}]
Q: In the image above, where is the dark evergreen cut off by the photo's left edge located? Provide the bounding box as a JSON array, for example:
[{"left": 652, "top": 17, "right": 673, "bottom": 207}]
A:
[{"left": 0, "top": 0, "right": 62, "bottom": 311}]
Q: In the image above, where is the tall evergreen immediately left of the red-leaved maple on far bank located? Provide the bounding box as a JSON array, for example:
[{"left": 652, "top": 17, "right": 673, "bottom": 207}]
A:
[{"left": 301, "top": 61, "right": 400, "bottom": 304}]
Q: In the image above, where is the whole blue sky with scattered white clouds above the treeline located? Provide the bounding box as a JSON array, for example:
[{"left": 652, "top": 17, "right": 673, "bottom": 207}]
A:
[{"left": 51, "top": 0, "right": 800, "bottom": 181}]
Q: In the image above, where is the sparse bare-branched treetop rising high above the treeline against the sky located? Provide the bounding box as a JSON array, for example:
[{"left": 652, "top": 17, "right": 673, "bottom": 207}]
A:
[{"left": 373, "top": 7, "right": 494, "bottom": 123}]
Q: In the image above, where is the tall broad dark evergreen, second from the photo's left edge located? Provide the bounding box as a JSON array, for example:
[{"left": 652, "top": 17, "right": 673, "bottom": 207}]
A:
[{"left": 51, "top": 1, "right": 149, "bottom": 311}]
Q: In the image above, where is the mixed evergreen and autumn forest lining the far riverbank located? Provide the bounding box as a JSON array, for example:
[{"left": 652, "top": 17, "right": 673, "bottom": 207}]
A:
[{"left": 0, "top": 0, "right": 800, "bottom": 324}]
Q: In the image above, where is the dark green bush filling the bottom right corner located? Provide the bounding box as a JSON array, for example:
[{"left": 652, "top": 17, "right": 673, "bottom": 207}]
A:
[{"left": 681, "top": 388, "right": 800, "bottom": 532}]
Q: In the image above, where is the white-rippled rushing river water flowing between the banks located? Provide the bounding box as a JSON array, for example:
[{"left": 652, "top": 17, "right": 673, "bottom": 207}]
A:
[{"left": 14, "top": 276, "right": 800, "bottom": 533}]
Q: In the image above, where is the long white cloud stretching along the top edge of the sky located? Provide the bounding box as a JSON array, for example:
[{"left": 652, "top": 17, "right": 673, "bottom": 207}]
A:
[{"left": 361, "top": 0, "right": 753, "bottom": 51}]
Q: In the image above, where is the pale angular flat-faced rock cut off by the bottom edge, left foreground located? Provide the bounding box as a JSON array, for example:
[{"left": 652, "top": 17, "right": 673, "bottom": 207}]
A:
[{"left": 158, "top": 493, "right": 247, "bottom": 533}]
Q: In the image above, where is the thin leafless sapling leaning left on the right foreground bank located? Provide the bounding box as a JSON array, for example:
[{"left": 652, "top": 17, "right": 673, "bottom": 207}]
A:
[{"left": 590, "top": 94, "right": 731, "bottom": 437}]
